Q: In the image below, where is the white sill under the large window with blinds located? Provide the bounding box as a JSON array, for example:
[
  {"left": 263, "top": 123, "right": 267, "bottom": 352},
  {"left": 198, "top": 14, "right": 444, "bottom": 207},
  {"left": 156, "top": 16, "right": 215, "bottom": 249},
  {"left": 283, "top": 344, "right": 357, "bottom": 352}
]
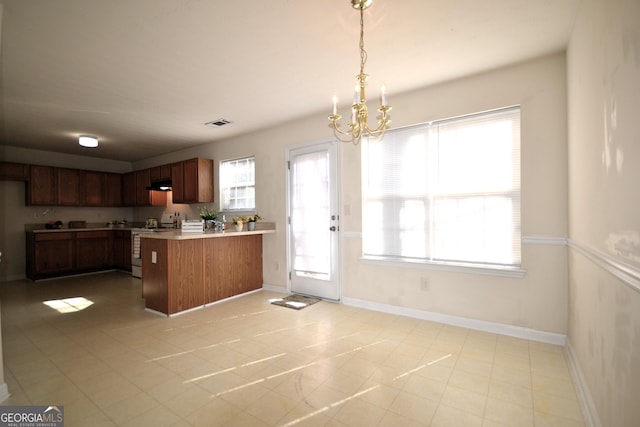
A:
[{"left": 360, "top": 256, "right": 526, "bottom": 279}]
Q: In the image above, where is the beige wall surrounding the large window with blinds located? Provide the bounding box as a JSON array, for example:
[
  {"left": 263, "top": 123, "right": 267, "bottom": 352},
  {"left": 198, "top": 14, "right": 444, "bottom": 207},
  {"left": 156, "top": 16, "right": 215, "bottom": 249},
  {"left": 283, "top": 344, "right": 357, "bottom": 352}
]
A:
[{"left": 343, "top": 54, "right": 567, "bottom": 334}]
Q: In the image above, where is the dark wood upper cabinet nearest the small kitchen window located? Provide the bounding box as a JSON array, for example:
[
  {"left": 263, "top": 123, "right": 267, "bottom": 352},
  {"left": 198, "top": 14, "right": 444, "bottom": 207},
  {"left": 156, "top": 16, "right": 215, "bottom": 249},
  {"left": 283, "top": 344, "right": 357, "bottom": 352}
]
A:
[{"left": 171, "top": 157, "right": 213, "bottom": 203}]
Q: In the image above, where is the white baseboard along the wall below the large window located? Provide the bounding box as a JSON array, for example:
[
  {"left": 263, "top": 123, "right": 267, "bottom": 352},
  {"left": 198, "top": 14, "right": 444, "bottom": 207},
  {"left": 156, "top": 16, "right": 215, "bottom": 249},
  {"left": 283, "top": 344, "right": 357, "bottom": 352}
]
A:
[{"left": 342, "top": 297, "right": 567, "bottom": 346}]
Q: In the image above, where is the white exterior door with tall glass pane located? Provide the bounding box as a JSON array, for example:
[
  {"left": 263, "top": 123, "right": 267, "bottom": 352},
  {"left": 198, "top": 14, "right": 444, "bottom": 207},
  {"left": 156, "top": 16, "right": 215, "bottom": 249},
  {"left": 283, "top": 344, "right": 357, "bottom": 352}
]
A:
[{"left": 288, "top": 142, "right": 340, "bottom": 301}]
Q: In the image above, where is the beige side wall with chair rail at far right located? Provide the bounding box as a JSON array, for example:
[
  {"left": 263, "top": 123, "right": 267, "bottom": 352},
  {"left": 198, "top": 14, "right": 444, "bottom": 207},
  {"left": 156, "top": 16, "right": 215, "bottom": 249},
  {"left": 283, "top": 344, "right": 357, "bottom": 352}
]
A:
[{"left": 568, "top": 0, "right": 640, "bottom": 426}]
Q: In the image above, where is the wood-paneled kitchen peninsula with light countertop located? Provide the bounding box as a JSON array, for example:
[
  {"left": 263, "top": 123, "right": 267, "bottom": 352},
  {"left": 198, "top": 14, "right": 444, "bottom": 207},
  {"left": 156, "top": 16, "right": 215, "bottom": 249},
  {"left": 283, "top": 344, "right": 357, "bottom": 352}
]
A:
[{"left": 141, "top": 229, "right": 275, "bottom": 316}]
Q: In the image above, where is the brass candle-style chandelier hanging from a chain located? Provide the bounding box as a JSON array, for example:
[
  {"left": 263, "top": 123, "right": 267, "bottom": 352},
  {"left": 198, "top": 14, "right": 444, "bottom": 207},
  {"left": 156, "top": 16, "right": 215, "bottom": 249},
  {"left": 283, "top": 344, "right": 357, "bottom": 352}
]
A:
[{"left": 329, "top": 0, "right": 391, "bottom": 145}]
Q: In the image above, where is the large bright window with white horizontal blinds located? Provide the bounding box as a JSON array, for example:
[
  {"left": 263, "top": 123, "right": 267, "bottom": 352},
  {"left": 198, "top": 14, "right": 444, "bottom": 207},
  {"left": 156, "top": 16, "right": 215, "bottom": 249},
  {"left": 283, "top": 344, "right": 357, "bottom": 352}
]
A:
[{"left": 362, "top": 107, "right": 521, "bottom": 269}]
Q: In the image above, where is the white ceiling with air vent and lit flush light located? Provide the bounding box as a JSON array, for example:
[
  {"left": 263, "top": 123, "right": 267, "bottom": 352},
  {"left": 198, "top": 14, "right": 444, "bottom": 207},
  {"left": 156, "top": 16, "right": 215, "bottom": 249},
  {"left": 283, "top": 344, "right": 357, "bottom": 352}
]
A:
[{"left": 0, "top": 0, "right": 581, "bottom": 161}]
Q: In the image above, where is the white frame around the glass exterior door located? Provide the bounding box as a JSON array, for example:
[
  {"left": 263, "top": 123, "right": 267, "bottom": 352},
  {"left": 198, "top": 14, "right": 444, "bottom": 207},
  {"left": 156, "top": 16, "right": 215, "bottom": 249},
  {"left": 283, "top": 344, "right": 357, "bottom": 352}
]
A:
[{"left": 284, "top": 138, "right": 343, "bottom": 303}]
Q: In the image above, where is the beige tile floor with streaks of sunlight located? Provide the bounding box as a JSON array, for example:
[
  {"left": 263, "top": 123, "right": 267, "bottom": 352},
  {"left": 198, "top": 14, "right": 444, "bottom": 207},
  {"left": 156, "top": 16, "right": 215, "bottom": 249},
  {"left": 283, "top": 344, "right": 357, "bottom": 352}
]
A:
[{"left": 0, "top": 272, "right": 585, "bottom": 427}]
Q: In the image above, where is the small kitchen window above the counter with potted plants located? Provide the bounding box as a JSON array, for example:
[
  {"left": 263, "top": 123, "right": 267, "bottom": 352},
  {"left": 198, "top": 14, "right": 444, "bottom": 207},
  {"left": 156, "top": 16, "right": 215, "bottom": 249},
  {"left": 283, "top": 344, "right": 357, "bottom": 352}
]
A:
[{"left": 220, "top": 157, "right": 256, "bottom": 211}]
